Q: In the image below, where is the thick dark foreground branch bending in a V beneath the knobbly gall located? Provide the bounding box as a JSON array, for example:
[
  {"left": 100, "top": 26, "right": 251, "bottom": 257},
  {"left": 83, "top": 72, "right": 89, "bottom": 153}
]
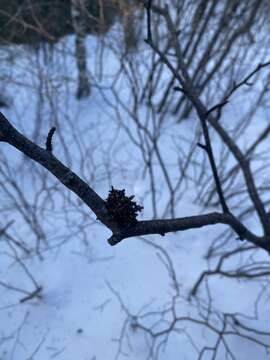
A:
[{"left": 0, "top": 112, "right": 270, "bottom": 251}]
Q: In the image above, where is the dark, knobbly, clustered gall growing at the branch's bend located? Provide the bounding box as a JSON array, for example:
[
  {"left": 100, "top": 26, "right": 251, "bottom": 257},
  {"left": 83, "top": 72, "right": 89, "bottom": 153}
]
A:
[{"left": 106, "top": 186, "right": 143, "bottom": 227}]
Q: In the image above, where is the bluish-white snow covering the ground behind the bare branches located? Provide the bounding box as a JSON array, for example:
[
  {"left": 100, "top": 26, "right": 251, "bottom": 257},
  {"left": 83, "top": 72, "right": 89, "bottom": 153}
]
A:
[{"left": 0, "top": 25, "right": 270, "bottom": 360}]
